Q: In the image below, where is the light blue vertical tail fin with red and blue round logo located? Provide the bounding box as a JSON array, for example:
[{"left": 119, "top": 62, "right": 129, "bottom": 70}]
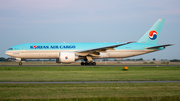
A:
[{"left": 138, "top": 19, "right": 165, "bottom": 44}]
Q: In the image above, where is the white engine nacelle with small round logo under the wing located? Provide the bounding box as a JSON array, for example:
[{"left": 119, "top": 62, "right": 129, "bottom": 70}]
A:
[{"left": 59, "top": 52, "right": 76, "bottom": 63}]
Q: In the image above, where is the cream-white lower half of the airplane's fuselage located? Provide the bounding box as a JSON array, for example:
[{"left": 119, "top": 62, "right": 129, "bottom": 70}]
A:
[{"left": 5, "top": 50, "right": 156, "bottom": 59}]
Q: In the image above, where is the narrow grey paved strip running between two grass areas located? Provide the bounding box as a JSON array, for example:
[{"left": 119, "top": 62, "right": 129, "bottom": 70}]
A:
[{"left": 0, "top": 81, "right": 180, "bottom": 84}]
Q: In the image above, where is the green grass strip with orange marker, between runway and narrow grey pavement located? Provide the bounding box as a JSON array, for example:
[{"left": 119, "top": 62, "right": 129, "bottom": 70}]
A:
[{"left": 0, "top": 66, "right": 180, "bottom": 81}]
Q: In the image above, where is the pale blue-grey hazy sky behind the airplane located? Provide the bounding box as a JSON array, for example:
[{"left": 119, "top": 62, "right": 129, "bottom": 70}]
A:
[{"left": 0, "top": 0, "right": 180, "bottom": 59}]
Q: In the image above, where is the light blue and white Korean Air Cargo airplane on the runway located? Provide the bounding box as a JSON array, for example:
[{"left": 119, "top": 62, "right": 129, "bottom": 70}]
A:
[{"left": 5, "top": 19, "right": 173, "bottom": 66}]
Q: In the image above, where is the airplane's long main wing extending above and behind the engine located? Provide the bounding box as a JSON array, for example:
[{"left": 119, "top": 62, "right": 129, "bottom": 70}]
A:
[{"left": 77, "top": 42, "right": 133, "bottom": 55}]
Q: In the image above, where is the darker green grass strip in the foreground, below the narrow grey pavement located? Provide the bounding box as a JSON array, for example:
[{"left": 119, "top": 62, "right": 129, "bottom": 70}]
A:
[{"left": 0, "top": 83, "right": 180, "bottom": 101}]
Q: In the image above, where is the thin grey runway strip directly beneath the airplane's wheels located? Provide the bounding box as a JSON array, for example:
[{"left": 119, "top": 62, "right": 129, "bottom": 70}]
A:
[{"left": 0, "top": 65, "right": 180, "bottom": 67}]
